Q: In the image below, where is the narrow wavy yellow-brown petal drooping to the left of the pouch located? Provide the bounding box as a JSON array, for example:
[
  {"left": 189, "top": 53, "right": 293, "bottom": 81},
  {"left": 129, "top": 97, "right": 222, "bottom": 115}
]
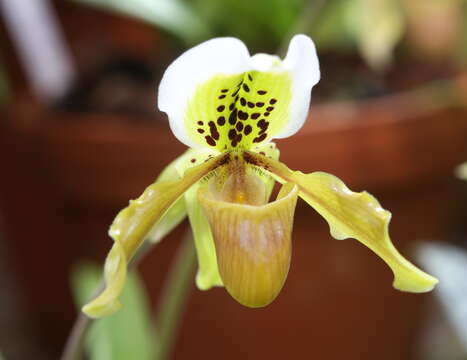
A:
[{"left": 83, "top": 155, "right": 231, "bottom": 318}]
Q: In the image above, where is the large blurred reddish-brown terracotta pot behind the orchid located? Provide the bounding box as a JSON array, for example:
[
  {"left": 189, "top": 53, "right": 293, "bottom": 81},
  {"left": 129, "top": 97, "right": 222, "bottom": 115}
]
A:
[{"left": 0, "top": 92, "right": 467, "bottom": 360}]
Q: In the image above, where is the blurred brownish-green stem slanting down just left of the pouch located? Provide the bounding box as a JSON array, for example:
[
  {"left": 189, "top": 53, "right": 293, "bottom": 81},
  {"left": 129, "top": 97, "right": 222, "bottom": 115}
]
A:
[{"left": 155, "top": 231, "right": 196, "bottom": 360}]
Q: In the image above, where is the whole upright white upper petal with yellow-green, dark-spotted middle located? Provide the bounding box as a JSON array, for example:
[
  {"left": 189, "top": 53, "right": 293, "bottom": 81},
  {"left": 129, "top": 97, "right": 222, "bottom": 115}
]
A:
[{"left": 159, "top": 35, "right": 319, "bottom": 151}]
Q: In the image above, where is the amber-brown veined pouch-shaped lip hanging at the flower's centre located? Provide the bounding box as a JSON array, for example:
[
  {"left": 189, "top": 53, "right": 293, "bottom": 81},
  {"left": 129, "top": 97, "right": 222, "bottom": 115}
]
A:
[{"left": 198, "top": 163, "right": 298, "bottom": 307}]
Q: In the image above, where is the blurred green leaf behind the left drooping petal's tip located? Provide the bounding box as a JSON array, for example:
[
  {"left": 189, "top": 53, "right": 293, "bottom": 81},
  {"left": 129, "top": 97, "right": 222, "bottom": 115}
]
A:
[{"left": 72, "top": 264, "right": 157, "bottom": 360}]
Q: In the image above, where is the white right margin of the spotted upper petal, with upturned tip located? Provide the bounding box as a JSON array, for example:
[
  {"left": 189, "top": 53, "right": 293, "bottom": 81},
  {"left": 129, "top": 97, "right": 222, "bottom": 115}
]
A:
[{"left": 274, "top": 34, "right": 320, "bottom": 138}]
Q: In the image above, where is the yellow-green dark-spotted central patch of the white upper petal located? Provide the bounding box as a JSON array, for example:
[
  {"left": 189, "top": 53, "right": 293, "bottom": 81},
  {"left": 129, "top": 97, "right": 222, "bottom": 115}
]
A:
[{"left": 185, "top": 71, "right": 291, "bottom": 151}]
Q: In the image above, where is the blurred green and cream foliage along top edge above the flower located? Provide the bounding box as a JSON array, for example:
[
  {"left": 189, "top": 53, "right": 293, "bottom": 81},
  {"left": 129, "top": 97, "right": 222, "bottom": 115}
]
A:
[{"left": 74, "top": 0, "right": 467, "bottom": 70}]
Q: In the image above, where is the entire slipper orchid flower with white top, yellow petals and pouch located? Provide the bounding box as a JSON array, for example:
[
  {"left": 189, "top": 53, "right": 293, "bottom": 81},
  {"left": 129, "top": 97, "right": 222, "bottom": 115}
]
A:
[{"left": 83, "top": 35, "right": 437, "bottom": 317}]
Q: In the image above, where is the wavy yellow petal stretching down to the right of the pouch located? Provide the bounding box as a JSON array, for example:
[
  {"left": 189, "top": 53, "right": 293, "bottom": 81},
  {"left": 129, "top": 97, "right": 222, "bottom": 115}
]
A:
[{"left": 245, "top": 153, "right": 438, "bottom": 292}]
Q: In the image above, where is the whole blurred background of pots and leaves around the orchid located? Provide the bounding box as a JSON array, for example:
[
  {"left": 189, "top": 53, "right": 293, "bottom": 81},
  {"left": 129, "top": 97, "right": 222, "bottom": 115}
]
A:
[{"left": 0, "top": 0, "right": 467, "bottom": 360}]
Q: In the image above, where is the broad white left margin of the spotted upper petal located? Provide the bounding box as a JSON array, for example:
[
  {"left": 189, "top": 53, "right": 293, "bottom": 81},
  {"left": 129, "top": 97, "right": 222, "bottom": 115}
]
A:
[{"left": 158, "top": 38, "right": 252, "bottom": 147}]
